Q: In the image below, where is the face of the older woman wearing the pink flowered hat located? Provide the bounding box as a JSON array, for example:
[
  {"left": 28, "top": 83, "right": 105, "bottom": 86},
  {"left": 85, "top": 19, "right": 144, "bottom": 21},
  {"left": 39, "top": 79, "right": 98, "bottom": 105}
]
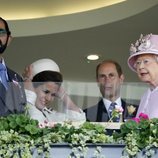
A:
[{"left": 135, "top": 54, "right": 158, "bottom": 87}]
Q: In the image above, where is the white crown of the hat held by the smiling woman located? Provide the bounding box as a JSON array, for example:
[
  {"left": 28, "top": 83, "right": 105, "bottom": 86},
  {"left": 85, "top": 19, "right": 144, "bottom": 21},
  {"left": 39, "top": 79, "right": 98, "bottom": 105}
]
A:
[{"left": 32, "top": 58, "right": 60, "bottom": 77}]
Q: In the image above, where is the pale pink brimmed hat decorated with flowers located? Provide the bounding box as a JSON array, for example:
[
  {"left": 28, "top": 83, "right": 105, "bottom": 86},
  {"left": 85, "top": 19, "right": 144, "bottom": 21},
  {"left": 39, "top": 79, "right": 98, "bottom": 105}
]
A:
[{"left": 128, "top": 34, "right": 158, "bottom": 71}]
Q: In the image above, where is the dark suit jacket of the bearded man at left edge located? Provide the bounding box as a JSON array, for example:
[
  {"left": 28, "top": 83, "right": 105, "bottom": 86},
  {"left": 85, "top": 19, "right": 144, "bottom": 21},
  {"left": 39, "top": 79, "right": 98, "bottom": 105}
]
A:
[{"left": 0, "top": 68, "right": 26, "bottom": 116}]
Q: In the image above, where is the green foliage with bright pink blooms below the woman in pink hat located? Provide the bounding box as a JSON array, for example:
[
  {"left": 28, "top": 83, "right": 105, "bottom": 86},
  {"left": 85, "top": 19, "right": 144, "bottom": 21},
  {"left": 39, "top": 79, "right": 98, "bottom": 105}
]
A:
[{"left": 115, "top": 113, "right": 158, "bottom": 158}]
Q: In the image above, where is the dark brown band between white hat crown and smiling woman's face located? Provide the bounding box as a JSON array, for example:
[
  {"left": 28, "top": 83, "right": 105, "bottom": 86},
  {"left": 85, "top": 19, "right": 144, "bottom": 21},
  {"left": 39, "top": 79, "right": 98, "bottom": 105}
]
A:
[{"left": 32, "top": 71, "right": 63, "bottom": 88}]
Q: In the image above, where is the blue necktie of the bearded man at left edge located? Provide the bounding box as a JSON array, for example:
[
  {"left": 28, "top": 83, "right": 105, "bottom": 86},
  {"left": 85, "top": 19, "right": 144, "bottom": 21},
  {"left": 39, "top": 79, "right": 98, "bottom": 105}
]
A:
[{"left": 0, "top": 63, "right": 8, "bottom": 89}]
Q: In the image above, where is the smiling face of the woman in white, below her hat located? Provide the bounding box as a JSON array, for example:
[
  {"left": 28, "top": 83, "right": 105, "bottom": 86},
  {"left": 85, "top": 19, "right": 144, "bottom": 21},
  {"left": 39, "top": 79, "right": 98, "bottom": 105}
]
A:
[{"left": 35, "top": 82, "right": 59, "bottom": 110}]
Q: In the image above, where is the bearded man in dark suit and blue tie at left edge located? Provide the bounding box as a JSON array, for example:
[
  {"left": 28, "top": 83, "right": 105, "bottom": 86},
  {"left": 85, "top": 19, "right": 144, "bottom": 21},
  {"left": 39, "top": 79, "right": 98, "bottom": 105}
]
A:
[{"left": 0, "top": 17, "right": 26, "bottom": 116}]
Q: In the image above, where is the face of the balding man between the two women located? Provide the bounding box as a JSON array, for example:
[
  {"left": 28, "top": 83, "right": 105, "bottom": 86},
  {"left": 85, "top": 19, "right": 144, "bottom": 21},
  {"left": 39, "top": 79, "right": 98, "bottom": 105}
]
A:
[{"left": 97, "top": 62, "right": 124, "bottom": 101}]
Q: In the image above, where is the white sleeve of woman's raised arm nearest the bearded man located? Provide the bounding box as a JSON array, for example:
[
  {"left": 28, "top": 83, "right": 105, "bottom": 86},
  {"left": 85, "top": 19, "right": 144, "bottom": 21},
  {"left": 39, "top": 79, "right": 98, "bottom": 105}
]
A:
[{"left": 25, "top": 89, "right": 37, "bottom": 105}]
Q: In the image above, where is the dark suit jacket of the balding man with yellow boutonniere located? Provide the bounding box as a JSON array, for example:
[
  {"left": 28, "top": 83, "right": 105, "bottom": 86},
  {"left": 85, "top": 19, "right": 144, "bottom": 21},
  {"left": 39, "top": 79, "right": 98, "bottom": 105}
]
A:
[{"left": 84, "top": 99, "right": 138, "bottom": 122}]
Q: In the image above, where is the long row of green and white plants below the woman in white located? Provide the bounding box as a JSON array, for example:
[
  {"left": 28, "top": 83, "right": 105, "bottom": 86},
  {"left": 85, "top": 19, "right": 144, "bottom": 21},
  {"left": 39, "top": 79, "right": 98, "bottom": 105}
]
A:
[{"left": 0, "top": 114, "right": 114, "bottom": 158}]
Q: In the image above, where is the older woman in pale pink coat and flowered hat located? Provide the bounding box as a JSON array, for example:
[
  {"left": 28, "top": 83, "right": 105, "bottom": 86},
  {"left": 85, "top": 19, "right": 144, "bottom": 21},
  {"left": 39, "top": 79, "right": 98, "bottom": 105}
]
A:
[{"left": 128, "top": 34, "right": 158, "bottom": 118}]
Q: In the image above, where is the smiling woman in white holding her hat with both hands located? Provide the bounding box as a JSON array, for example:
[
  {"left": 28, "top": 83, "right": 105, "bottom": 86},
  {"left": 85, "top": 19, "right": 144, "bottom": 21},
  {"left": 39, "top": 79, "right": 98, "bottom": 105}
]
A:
[{"left": 23, "top": 59, "right": 86, "bottom": 123}]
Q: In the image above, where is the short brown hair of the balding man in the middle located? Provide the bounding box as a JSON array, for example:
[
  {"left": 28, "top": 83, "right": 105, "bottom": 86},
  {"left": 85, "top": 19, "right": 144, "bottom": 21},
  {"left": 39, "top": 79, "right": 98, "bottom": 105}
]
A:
[{"left": 96, "top": 59, "right": 123, "bottom": 78}]
